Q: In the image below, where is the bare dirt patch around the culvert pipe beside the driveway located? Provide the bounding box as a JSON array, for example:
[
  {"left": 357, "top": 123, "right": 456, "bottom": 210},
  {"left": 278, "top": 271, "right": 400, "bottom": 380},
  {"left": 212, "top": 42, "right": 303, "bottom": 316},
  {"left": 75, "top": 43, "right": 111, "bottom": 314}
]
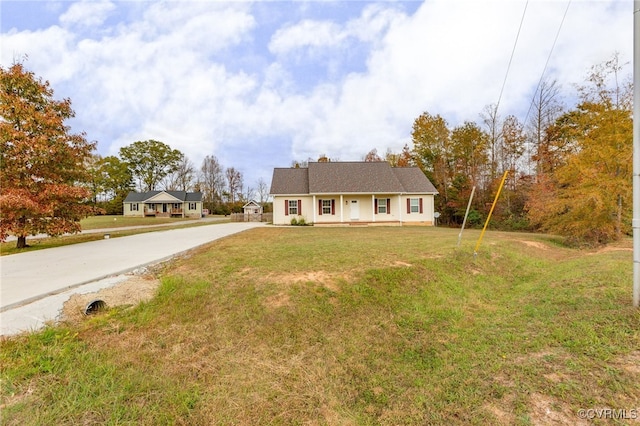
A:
[{"left": 60, "top": 275, "right": 160, "bottom": 322}]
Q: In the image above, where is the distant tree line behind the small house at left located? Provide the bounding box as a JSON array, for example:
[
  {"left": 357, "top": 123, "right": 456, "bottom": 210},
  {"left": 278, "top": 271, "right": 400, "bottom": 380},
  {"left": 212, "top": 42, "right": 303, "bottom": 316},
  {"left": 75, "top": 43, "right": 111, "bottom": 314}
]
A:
[{"left": 87, "top": 140, "right": 269, "bottom": 214}]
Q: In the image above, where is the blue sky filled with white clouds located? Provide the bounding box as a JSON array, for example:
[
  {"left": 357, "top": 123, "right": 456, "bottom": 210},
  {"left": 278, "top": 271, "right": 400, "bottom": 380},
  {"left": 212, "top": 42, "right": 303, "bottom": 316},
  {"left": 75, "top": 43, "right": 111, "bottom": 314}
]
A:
[{"left": 0, "top": 0, "right": 633, "bottom": 187}]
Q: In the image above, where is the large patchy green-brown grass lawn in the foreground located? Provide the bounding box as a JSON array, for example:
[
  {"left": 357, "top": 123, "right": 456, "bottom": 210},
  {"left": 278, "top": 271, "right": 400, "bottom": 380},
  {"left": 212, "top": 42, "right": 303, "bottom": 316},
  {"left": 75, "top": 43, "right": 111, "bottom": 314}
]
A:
[{"left": 0, "top": 227, "right": 640, "bottom": 425}]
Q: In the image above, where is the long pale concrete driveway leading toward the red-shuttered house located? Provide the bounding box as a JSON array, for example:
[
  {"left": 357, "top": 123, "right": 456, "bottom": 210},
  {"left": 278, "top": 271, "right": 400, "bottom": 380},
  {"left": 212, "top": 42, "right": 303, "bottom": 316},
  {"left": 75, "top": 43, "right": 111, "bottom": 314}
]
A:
[{"left": 0, "top": 222, "right": 265, "bottom": 335}]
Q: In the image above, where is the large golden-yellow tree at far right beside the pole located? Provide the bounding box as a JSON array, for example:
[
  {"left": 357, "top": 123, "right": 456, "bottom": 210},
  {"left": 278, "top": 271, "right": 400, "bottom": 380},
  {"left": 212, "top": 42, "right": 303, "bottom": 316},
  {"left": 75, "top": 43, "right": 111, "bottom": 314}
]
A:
[{"left": 527, "top": 58, "right": 633, "bottom": 244}]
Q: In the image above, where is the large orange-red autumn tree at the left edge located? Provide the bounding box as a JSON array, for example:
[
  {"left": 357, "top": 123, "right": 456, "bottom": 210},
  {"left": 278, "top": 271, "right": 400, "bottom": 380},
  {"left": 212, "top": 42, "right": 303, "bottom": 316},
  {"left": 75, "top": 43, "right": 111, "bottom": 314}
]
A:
[{"left": 0, "top": 63, "right": 95, "bottom": 248}]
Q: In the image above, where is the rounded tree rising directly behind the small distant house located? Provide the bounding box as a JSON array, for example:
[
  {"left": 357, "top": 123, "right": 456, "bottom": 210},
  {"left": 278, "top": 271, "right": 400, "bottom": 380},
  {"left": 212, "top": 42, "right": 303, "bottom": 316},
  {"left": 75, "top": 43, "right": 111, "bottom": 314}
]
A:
[{"left": 120, "top": 139, "right": 183, "bottom": 191}]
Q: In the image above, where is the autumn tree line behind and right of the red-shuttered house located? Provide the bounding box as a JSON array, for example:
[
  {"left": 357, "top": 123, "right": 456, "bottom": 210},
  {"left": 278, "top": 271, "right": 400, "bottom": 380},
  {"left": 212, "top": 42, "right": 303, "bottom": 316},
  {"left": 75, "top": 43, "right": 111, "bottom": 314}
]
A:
[{"left": 291, "top": 54, "right": 633, "bottom": 245}]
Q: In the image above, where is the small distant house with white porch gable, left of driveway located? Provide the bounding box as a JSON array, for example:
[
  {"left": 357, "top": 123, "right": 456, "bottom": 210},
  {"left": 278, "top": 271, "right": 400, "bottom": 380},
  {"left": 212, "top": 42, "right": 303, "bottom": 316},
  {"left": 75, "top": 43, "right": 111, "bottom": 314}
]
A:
[{"left": 123, "top": 191, "right": 202, "bottom": 218}]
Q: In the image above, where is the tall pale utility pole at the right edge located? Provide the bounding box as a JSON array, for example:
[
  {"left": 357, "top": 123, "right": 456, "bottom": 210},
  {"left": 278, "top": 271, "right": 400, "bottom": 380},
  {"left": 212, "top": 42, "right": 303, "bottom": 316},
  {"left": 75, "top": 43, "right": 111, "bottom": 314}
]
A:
[{"left": 631, "top": 0, "right": 640, "bottom": 308}]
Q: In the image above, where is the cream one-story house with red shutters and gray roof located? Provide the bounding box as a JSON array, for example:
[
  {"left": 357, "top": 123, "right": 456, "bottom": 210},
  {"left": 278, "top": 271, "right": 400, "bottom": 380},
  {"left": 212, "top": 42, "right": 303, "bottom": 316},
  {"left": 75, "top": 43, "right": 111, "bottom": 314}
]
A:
[{"left": 270, "top": 161, "right": 438, "bottom": 225}]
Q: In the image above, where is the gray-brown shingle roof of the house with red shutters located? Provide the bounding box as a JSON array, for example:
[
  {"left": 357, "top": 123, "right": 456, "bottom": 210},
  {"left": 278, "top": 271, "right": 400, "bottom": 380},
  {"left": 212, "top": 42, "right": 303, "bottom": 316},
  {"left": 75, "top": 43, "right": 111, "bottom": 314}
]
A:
[{"left": 270, "top": 161, "right": 438, "bottom": 195}]
